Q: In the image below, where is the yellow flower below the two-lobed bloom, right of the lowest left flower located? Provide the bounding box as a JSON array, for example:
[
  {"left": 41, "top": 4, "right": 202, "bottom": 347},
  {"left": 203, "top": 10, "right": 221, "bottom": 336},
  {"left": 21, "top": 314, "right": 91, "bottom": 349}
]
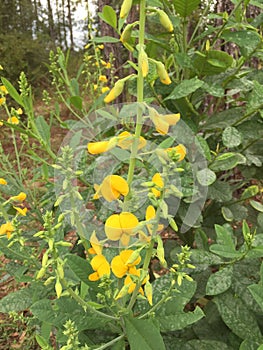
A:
[{"left": 111, "top": 249, "right": 141, "bottom": 278}]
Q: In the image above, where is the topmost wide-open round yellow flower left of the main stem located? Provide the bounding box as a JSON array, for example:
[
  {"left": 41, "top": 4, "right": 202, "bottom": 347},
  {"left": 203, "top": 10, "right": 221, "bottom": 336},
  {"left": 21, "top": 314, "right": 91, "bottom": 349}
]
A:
[{"left": 93, "top": 175, "right": 129, "bottom": 202}]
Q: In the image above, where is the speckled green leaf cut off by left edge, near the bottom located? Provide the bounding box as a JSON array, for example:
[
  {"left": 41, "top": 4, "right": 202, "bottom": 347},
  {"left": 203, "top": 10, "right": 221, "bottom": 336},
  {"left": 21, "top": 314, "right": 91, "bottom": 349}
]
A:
[{"left": 0, "top": 288, "right": 32, "bottom": 313}]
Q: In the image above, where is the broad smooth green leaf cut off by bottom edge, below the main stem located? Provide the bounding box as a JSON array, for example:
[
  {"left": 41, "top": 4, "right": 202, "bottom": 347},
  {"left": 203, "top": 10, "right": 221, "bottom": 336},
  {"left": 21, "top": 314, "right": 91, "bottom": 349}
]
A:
[{"left": 124, "top": 316, "right": 165, "bottom": 350}]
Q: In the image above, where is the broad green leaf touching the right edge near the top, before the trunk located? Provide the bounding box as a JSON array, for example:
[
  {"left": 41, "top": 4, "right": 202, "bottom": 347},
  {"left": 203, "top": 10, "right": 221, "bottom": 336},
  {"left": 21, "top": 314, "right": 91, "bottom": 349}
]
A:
[{"left": 222, "top": 29, "right": 261, "bottom": 57}]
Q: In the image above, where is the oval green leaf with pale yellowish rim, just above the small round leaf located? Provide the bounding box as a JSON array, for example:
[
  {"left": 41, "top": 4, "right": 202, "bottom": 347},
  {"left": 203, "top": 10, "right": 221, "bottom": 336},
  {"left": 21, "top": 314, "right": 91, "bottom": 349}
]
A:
[{"left": 210, "top": 152, "right": 246, "bottom": 171}]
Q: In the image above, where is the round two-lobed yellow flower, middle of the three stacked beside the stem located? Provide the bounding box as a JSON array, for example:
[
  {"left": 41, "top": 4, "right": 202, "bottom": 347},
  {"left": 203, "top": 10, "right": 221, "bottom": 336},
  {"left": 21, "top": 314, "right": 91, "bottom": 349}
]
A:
[{"left": 105, "top": 212, "right": 139, "bottom": 246}]
